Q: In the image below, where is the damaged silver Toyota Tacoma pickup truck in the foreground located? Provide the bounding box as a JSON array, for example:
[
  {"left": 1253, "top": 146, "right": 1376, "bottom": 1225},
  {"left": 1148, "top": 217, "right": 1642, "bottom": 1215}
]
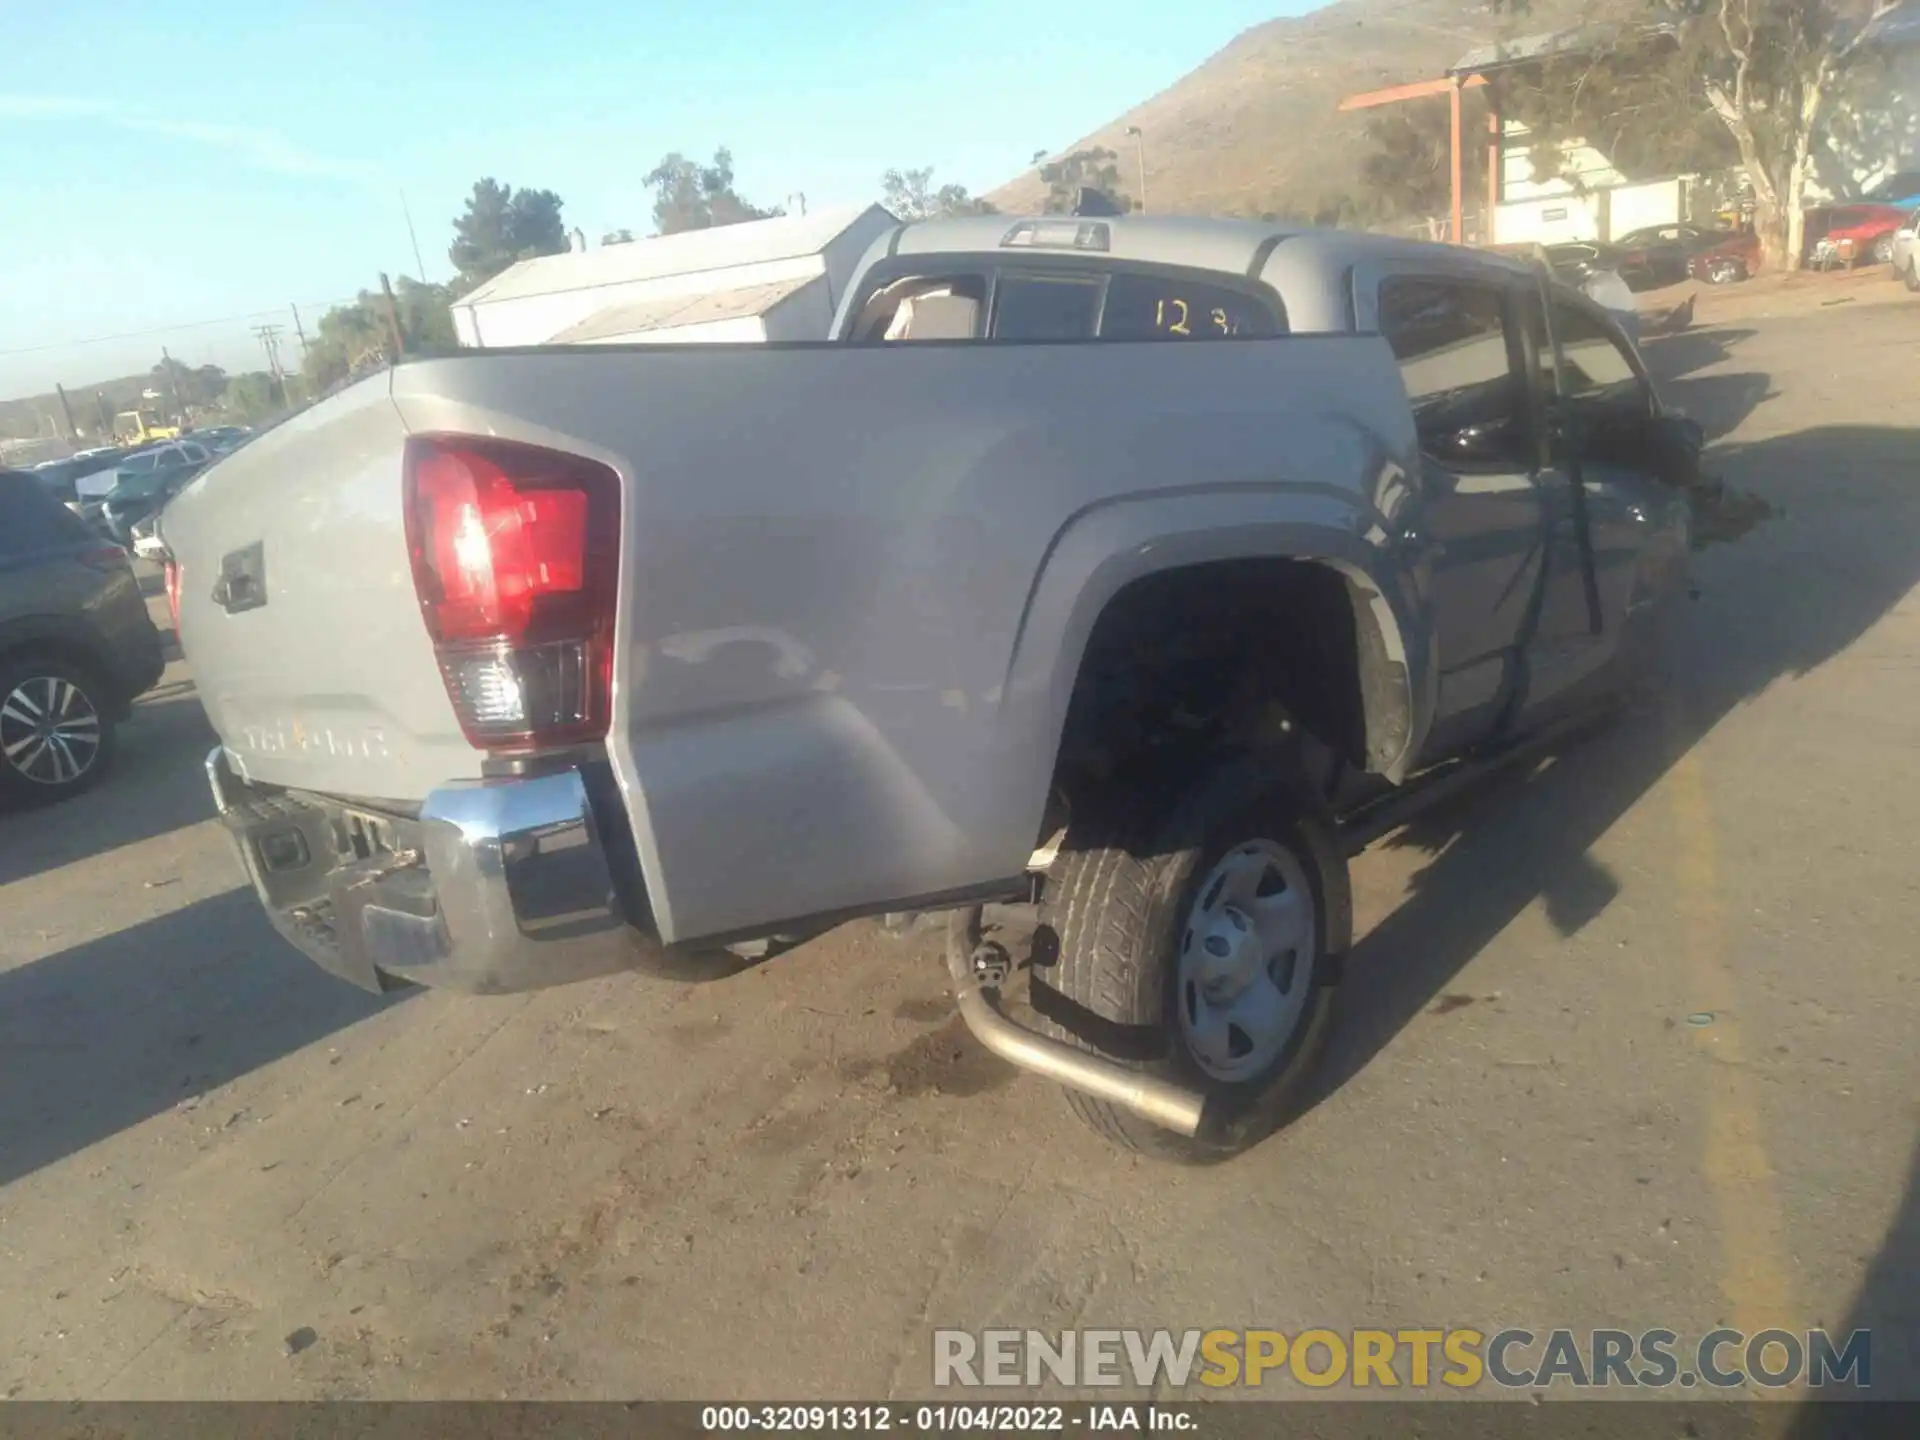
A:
[{"left": 163, "top": 215, "right": 1699, "bottom": 1160}]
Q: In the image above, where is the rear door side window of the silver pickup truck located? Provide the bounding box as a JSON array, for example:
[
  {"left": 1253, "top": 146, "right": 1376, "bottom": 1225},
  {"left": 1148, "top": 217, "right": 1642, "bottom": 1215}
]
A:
[{"left": 1380, "top": 276, "right": 1532, "bottom": 468}]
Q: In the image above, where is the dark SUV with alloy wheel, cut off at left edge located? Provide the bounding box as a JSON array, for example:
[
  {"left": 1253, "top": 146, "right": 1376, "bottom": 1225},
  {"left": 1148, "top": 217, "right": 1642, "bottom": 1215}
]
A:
[{"left": 0, "top": 470, "right": 165, "bottom": 803}]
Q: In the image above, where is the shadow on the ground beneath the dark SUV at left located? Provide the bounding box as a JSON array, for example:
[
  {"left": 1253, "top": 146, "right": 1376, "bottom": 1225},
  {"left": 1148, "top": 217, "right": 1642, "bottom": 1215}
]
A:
[{"left": 0, "top": 682, "right": 217, "bottom": 885}]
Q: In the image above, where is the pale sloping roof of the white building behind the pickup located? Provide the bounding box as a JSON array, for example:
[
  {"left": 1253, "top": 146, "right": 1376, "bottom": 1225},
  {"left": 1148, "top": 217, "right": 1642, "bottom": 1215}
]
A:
[{"left": 457, "top": 205, "right": 885, "bottom": 305}]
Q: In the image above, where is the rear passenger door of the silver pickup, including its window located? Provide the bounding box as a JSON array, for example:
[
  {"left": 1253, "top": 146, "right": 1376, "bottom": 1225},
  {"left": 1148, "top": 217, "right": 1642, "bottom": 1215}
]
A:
[{"left": 1379, "top": 273, "right": 1546, "bottom": 760}]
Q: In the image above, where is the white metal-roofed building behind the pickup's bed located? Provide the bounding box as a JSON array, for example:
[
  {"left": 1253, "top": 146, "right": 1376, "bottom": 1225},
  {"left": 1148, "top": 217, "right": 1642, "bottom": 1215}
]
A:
[{"left": 453, "top": 205, "right": 897, "bottom": 348}]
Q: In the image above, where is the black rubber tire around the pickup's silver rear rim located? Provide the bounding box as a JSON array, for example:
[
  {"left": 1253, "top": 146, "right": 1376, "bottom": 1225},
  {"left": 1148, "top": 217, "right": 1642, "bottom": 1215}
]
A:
[{"left": 1033, "top": 770, "right": 1354, "bottom": 1164}]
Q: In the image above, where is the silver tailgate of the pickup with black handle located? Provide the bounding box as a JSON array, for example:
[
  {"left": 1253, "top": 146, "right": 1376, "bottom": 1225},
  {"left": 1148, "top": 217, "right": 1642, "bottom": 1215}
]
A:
[{"left": 161, "top": 374, "right": 480, "bottom": 801}]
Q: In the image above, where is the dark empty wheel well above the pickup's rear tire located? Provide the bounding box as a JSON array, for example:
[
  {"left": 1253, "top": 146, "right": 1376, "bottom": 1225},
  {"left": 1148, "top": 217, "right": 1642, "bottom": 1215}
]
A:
[{"left": 1043, "top": 559, "right": 1386, "bottom": 841}]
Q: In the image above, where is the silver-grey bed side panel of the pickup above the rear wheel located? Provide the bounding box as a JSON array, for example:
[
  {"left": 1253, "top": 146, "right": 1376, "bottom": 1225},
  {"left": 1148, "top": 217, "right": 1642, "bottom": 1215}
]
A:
[{"left": 394, "top": 336, "right": 1425, "bottom": 941}]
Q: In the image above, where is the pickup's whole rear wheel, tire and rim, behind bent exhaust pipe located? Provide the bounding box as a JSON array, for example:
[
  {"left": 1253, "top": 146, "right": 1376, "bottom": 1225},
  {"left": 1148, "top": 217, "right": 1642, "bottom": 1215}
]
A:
[{"left": 1035, "top": 760, "right": 1352, "bottom": 1164}]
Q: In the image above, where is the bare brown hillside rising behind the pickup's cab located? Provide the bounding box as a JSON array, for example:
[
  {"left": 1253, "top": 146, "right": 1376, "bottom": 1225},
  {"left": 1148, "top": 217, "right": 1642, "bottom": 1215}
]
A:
[{"left": 989, "top": 0, "right": 1622, "bottom": 215}]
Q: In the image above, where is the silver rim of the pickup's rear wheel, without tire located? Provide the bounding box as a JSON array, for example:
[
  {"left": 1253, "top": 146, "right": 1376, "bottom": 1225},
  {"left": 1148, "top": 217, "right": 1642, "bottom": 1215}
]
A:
[{"left": 1177, "top": 839, "right": 1319, "bottom": 1083}]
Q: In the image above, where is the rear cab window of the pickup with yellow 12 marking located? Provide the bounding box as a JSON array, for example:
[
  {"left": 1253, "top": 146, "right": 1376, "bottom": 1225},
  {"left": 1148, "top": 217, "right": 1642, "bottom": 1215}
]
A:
[{"left": 847, "top": 252, "right": 1286, "bottom": 344}]
